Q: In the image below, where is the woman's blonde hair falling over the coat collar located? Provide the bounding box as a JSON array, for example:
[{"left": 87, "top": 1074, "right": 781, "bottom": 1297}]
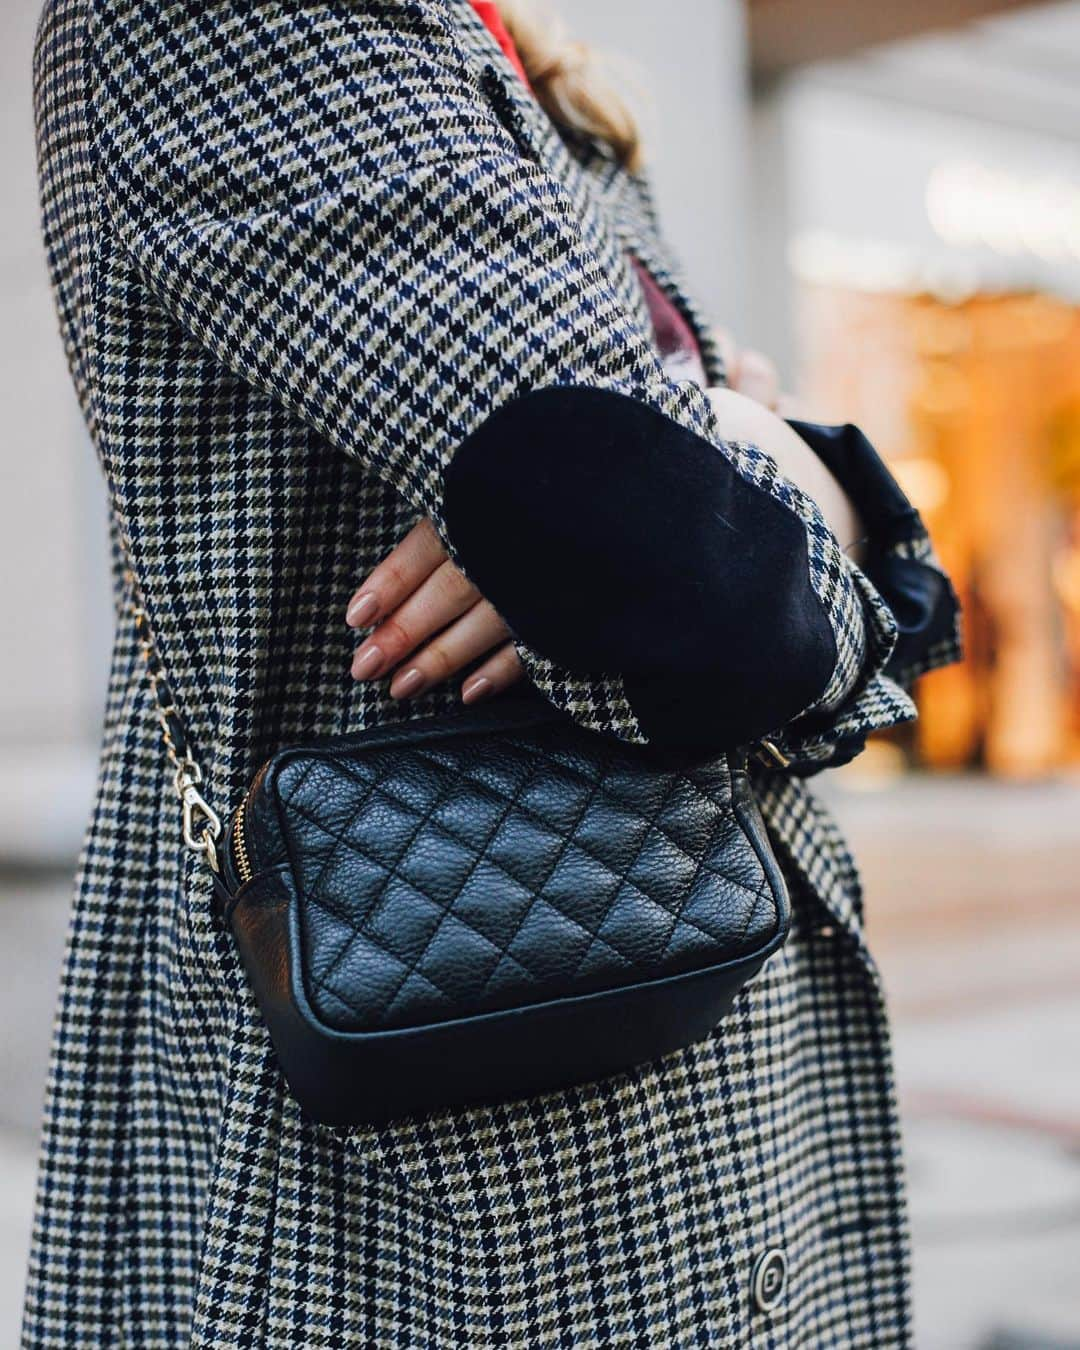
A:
[{"left": 497, "top": 0, "right": 643, "bottom": 173}]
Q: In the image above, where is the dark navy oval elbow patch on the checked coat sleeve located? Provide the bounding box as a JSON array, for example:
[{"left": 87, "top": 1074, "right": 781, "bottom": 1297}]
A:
[{"left": 444, "top": 386, "right": 837, "bottom": 747}]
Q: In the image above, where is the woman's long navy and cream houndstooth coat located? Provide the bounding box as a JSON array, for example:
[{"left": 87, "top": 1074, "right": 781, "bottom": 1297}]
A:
[{"left": 24, "top": 0, "right": 956, "bottom": 1350}]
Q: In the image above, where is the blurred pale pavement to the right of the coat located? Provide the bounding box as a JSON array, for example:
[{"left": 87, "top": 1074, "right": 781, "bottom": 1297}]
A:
[{"left": 828, "top": 774, "right": 1080, "bottom": 1350}]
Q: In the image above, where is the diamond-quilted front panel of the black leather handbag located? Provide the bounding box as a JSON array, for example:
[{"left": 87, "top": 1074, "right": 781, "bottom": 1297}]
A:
[{"left": 248, "top": 718, "right": 780, "bottom": 1031}]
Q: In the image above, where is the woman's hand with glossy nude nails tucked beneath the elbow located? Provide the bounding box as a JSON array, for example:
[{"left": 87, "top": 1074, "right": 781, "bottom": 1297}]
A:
[{"left": 346, "top": 520, "right": 524, "bottom": 703}]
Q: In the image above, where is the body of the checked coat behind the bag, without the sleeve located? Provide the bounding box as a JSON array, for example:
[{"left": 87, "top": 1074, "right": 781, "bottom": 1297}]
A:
[{"left": 21, "top": 0, "right": 905, "bottom": 1350}]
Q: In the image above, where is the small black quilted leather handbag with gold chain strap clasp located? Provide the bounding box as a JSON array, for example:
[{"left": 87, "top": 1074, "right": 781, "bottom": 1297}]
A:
[{"left": 139, "top": 591, "right": 788, "bottom": 1125}]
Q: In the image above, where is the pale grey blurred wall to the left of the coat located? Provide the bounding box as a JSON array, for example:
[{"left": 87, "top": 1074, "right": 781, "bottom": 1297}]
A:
[{"left": 0, "top": 0, "right": 108, "bottom": 860}]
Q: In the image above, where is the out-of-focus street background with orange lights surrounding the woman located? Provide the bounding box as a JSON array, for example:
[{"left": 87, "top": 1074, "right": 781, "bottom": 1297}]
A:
[{"left": 0, "top": 0, "right": 1080, "bottom": 1350}]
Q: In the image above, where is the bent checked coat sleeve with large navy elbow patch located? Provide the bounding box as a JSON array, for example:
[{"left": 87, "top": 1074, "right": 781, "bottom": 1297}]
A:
[{"left": 89, "top": 0, "right": 955, "bottom": 747}]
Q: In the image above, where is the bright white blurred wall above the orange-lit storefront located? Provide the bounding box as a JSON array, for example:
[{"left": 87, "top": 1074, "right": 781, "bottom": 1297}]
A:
[{"left": 751, "top": 3, "right": 1080, "bottom": 366}]
